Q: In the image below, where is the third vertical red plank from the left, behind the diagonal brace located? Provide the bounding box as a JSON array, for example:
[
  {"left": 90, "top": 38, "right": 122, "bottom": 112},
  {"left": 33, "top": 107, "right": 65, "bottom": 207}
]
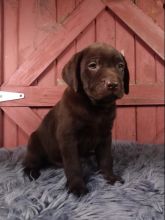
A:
[{"left": 33, "top": 0, "right": 57, "bottom": 132}]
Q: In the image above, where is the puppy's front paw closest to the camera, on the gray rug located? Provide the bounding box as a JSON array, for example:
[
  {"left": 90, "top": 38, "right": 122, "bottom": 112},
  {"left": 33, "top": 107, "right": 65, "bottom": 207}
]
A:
[{"left": 69, "top": 181, "right": 89, "bottom": 197}]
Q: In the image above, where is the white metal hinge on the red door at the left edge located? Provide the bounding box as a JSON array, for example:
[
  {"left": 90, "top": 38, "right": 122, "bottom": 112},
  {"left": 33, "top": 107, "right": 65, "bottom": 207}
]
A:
[{"left": 0, "top": 91, "right": 25, "bottom": 102}]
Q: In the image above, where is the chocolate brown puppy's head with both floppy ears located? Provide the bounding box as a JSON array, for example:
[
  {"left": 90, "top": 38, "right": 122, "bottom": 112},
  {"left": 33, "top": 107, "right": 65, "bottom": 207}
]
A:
[{"left": 62, "top": 43, "right": 129, "bottom": 101}]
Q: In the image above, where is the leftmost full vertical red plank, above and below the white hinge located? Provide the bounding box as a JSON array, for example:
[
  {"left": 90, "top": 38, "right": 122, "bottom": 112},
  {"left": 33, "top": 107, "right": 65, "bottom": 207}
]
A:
[{"left": 3, "top": 1, "right": 19, "bottom": 146}]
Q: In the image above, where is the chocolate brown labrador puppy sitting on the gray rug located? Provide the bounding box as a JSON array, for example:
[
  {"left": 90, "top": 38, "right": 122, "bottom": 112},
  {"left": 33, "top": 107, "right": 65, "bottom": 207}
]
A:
[{"left": 24, "top": 43, "right": 129, "bottom": 196}]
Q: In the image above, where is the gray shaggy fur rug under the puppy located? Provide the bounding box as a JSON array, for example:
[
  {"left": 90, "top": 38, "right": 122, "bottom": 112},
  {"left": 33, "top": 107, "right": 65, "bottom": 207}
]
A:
[{"left": 0, "top": 142, "right": 164, "bottom": 220}]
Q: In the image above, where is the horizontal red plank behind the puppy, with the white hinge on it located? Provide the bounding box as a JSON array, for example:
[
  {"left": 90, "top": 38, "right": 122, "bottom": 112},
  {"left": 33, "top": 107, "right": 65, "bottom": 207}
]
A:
[{"left": 0, "top": 84, "right": 164, "bottom": 107}]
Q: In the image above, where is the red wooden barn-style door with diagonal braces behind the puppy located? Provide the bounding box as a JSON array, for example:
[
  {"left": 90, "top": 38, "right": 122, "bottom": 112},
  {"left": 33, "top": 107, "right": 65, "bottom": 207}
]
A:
[{"left": 0, "top": 0, "right": 164, "bottom": 146}]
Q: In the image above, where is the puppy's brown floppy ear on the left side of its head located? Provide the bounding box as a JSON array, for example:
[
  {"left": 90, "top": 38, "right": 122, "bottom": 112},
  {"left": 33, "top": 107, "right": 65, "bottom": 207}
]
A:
[{"left": 62, "top": 52, "right": 82, "bottom": 92}]
